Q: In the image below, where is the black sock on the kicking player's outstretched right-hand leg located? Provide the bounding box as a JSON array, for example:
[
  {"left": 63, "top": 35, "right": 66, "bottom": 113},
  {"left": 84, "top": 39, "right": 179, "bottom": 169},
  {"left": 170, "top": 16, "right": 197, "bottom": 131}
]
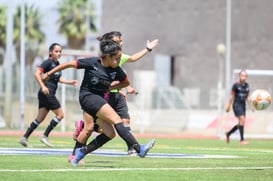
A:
[{"left": 115, "top": 123, "right": 140, "bottom": 153}]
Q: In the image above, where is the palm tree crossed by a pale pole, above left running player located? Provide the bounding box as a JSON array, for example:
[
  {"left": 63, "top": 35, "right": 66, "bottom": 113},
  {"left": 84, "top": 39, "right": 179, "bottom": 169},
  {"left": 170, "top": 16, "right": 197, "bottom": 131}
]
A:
[{"left": 13, "top": 5, "right": 45, "bottom": 65}]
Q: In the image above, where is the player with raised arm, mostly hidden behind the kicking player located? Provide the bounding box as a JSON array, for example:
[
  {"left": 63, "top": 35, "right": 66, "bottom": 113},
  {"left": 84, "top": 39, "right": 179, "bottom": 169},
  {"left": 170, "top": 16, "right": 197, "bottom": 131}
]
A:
[{"left": 69, "top": 31, "right": 158, "bottom": 156}]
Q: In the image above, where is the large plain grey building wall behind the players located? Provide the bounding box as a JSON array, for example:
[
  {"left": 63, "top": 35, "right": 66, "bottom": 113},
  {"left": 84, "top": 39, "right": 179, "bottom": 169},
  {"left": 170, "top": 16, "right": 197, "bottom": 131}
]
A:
[{"left": 102, "top": 0, "right": 273, "bottom": 109}]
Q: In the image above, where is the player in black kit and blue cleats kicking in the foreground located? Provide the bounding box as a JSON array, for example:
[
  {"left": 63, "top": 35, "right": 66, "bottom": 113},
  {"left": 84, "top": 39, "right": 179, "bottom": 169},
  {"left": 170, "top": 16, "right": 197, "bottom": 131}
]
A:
[{"left": 44, "top": 40, "right": 155, "bottom": 166}]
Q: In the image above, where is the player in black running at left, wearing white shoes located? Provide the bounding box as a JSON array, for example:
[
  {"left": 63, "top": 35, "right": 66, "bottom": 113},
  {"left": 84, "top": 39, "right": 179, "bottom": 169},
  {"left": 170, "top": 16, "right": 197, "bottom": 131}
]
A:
[{"left": 19, "top": 43, "right": 77, "bottom": 147}]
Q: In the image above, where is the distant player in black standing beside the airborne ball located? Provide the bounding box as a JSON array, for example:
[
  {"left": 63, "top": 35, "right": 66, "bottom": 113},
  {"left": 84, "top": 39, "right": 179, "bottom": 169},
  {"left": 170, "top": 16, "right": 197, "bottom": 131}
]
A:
[{"left": 226, "top": 70, "right": 250, "bottom": 144}]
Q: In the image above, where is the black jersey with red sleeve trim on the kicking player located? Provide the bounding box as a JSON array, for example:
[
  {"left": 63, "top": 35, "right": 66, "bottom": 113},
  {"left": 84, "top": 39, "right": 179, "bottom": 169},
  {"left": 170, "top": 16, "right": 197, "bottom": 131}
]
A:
[{"left": 77, "top": 57, "right": 127, "bottom": 96}]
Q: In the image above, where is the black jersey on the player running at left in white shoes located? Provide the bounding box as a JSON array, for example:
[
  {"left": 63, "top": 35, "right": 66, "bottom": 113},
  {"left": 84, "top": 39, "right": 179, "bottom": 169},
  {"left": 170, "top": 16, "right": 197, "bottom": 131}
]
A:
[{"left": 39, "top": 59, "right": 62, "bottom": 94}]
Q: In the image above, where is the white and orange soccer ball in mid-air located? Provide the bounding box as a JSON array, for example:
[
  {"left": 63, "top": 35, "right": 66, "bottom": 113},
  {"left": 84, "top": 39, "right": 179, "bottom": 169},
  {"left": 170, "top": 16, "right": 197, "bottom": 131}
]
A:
[{"left": 250, "top": 89, "right": 271, "bottom": 110}]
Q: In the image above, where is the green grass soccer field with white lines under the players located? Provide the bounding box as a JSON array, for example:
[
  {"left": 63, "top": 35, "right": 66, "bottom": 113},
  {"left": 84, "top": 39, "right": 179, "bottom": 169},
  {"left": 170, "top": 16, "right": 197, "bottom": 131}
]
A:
[{"left": 0, "top": 136, "right": 273, "bottom": 181}]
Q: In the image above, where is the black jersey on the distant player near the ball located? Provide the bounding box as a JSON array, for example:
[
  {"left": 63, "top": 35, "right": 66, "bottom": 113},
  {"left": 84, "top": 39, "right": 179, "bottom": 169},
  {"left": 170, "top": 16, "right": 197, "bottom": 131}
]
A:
[{"left": 232, "top": 83, "right": 249, "bottom": 103}]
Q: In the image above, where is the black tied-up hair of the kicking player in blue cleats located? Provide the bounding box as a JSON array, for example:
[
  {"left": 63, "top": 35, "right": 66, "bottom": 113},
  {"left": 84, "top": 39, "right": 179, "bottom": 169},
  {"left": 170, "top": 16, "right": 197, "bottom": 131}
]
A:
[{"left": 100, "top": 39, "right": 121, "bottom": 58}]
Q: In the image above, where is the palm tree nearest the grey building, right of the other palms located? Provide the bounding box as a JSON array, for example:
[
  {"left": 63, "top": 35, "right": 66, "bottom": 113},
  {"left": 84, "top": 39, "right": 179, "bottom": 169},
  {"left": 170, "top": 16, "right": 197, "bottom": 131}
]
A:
[{"left": 57, "top": 0, "right": 96, "bottom": 49}]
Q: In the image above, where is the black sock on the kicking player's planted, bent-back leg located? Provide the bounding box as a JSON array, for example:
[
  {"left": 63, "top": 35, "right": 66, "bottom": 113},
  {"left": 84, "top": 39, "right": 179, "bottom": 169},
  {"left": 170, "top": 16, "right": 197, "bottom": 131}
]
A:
[{"left": 81, "top": 133, "right": 111, "bottom": 154}]
